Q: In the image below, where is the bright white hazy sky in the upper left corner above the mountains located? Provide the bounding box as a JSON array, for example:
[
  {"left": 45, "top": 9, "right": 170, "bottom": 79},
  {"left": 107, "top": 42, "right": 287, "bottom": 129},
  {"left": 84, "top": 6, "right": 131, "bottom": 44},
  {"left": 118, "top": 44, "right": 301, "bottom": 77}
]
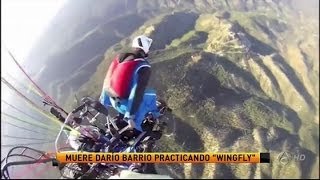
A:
[{"left": 1, "top": 0, "right": 66, "bottom": 64}]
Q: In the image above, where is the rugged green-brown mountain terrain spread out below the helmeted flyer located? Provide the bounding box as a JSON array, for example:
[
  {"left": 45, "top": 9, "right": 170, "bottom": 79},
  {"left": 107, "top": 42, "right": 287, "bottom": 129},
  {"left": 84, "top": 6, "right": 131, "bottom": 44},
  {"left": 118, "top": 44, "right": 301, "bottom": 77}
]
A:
[{"left": 23, "top": 0, "right": 319, "bottom": 178}]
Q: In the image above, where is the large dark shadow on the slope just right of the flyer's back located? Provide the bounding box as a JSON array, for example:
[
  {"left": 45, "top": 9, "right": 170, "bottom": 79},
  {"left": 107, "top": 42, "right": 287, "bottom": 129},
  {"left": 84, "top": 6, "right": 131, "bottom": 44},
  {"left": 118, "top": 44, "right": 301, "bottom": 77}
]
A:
[{"left": 149, "top": 53, "right": 262, "bottom": 106}]
